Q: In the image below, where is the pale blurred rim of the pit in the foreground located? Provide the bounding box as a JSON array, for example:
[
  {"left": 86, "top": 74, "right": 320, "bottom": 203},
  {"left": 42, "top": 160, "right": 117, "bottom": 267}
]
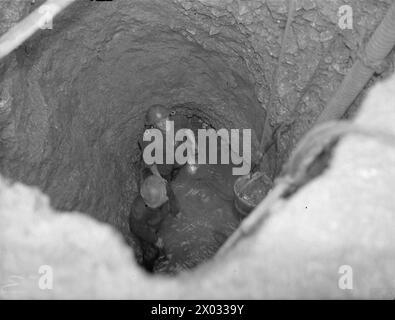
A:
[{"left": 0, "top": 73, "right": 395, "bottom": 299}]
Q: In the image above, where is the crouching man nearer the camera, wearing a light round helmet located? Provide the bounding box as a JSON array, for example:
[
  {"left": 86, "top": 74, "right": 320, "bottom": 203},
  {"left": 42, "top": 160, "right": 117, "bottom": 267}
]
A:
[{"left": 129, "top": 175, "right": 179, "bottom": 270}]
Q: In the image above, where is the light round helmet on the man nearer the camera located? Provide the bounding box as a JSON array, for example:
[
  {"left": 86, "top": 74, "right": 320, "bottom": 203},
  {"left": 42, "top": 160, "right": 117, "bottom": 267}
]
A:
[{"left": 140, "top": 175, "right": 169, "bottom": 209}]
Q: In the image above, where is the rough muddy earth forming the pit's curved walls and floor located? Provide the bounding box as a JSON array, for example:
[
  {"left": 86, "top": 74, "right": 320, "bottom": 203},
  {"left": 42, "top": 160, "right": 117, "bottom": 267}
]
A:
[{"left": 0, "top": 0, "right": 394, "bottom": 274}]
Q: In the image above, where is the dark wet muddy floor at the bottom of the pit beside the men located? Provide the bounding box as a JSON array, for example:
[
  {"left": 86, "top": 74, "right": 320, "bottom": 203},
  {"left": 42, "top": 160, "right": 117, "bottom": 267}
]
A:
[{"left": 130, "top": 114, "right": 251, "bottom": 274}]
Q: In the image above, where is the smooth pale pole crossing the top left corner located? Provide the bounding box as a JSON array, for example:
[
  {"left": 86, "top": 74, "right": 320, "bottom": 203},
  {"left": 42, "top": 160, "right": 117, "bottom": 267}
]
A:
[{"left": 0, "top": 0, "right": 76, "bottom": 60}]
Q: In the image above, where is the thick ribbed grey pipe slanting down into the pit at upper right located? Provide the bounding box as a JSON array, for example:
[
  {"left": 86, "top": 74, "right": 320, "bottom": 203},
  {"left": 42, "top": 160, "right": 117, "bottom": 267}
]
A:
[{"left": 316, "top": 1, "right": 395, "bottom": 124}]
